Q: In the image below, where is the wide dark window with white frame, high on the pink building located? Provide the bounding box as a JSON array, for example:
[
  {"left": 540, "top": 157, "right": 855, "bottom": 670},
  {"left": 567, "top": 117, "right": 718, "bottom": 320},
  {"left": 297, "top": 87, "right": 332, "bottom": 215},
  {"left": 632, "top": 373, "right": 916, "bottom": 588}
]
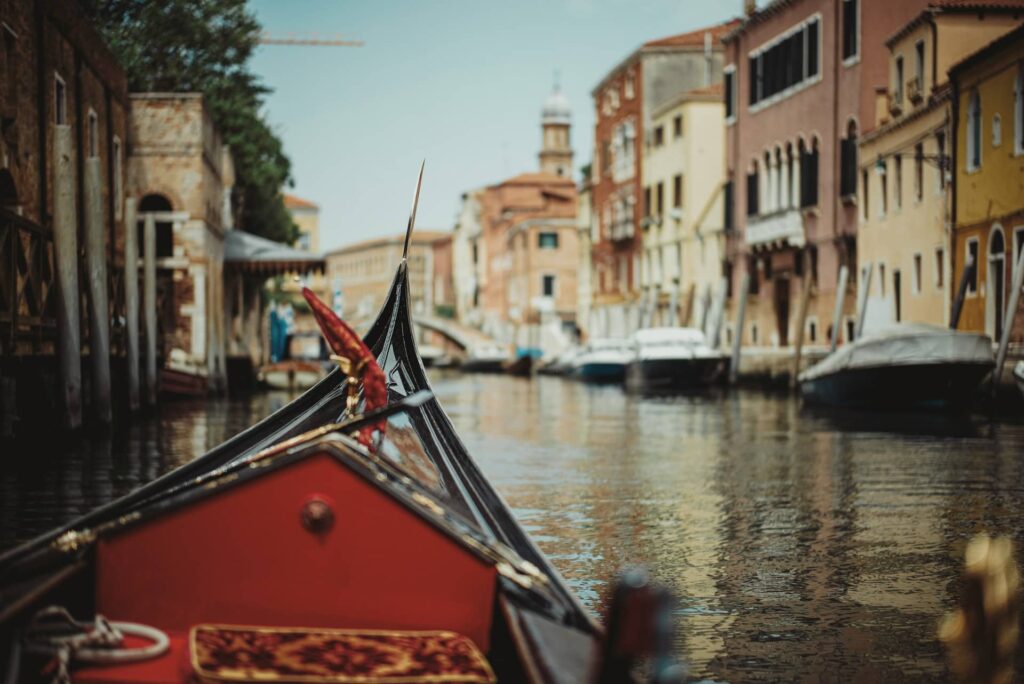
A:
[{"left": 749, "top": 16, "right": 819, "bottom": 107}]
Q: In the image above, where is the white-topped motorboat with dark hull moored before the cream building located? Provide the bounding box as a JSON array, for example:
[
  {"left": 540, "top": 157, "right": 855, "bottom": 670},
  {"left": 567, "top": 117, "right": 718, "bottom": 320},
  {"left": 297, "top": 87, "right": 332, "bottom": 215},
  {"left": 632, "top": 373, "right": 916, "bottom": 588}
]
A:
[{"left": 626, "top": 328, "right": 727, "bottom": 392}]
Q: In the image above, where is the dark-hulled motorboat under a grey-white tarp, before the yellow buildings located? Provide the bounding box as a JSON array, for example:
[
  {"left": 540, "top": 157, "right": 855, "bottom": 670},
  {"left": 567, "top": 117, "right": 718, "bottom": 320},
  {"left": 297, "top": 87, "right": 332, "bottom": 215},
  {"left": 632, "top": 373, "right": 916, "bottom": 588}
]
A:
[{"left": 798, "top": 323, "right": 995, "bottom": 409}]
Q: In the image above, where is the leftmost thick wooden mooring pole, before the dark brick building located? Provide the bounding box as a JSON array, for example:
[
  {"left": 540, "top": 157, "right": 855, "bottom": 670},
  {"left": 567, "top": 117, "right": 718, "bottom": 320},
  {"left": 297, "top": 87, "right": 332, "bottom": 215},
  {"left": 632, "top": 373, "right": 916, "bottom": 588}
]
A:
[{"left": 53, "top": 125, "right": 82, "bottom": 430}]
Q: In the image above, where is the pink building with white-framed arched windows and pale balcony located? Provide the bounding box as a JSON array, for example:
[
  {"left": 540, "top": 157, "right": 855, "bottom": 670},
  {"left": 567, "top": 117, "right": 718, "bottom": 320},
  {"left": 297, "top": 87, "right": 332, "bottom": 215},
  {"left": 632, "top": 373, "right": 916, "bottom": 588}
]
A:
[{"left": 724, "top": 0, "right": 928, "bottom": 347}]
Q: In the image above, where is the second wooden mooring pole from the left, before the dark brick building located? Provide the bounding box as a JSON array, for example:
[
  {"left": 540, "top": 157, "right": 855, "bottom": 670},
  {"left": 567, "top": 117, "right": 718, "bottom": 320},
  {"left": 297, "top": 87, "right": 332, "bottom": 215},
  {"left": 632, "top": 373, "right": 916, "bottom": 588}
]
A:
[{"left": 83, "top": 157, "right": 111, "bottom": 423}]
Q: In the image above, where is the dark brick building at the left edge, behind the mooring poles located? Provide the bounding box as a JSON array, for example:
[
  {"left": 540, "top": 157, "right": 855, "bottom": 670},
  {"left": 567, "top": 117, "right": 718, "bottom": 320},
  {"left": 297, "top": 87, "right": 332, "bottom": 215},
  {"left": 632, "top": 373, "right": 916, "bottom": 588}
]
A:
[{"left": 0, "top": 0, "right": 132, "bottom": 429}]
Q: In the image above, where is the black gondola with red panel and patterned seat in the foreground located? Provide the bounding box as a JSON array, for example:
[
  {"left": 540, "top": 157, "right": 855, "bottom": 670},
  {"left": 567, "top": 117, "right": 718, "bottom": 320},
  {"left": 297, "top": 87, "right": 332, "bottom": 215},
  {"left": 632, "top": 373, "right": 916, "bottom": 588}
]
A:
[{"left": 0, "top": 171, "right": 667, "bottom": 682}]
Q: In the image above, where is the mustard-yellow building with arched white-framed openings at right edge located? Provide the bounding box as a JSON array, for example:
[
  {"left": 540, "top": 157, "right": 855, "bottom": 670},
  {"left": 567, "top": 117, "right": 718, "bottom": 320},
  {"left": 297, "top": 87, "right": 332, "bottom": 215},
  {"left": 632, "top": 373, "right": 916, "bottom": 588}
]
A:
[{"left": 949, "top": 26, "right": 1024, "bottom": 345}]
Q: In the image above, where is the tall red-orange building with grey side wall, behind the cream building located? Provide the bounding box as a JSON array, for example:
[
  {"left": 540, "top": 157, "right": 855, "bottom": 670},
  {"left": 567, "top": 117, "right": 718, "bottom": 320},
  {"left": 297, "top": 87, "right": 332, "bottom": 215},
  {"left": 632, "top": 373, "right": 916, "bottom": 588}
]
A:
[{"left": 589, "top": 22, "right": 736, "bottom": 337}]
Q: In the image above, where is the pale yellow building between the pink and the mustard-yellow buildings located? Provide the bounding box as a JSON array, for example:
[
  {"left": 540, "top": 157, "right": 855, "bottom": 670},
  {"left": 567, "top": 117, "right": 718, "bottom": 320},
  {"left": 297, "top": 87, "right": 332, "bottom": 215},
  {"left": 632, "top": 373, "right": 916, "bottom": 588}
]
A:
[{"left": 860, "top": 4, "right": 1019, "bottom": 331}]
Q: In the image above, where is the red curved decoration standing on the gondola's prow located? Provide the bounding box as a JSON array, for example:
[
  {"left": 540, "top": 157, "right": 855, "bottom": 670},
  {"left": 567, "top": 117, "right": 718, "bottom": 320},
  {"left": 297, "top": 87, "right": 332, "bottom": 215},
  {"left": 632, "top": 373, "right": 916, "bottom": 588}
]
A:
[{"left": 302, "top": 288, "right": 387, "bottom": 448}]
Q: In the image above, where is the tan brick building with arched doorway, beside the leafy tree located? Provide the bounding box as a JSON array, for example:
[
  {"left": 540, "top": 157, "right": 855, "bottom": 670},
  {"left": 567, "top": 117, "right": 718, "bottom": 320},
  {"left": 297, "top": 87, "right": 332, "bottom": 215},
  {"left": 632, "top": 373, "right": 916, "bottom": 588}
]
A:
[{"left": 128, "top": 93, "right": 234, "bottom": 390}]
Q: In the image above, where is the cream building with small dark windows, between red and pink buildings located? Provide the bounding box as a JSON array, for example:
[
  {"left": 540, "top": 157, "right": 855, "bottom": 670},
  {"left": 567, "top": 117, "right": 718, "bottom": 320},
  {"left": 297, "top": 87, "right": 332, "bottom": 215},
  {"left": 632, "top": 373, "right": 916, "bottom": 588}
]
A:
[{"left": 640, "top": 84, "right": 725, "bottom": 328}]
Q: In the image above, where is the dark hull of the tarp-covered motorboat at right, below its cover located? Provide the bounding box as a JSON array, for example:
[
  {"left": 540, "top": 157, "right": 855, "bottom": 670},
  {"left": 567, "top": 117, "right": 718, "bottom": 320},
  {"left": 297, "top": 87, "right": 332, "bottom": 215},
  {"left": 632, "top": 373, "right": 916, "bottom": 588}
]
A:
[{"left": 800, "top": 362, "right": 992, "bottom": 409}]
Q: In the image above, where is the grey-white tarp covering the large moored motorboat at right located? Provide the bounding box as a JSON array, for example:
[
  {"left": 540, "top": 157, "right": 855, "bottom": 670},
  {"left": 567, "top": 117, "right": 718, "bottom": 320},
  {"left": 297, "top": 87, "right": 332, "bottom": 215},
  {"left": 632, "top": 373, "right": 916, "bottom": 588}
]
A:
[{"left": 799, "top": 323, "right": 994, "bottom": 382}]
